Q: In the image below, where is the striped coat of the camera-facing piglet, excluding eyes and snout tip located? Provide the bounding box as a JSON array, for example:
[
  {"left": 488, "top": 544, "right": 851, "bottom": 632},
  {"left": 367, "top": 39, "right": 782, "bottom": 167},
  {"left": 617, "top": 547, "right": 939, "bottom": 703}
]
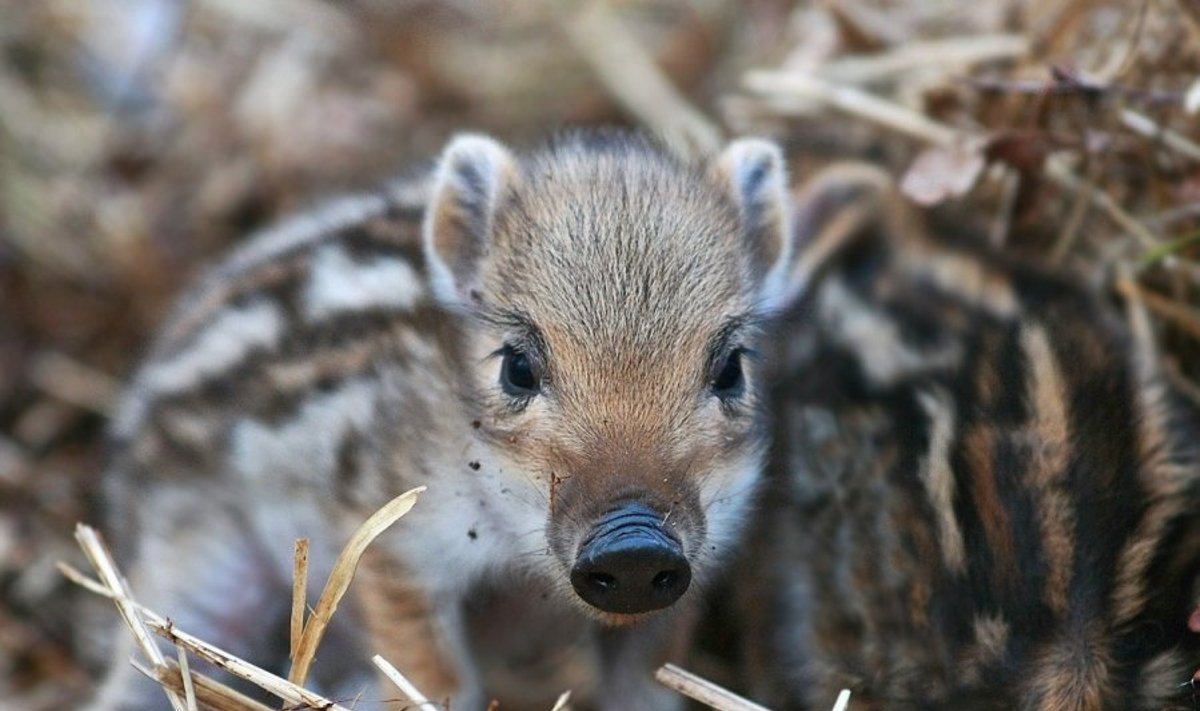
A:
[{"left": 87, "top": 135, "right": 792, "bottom": 711}]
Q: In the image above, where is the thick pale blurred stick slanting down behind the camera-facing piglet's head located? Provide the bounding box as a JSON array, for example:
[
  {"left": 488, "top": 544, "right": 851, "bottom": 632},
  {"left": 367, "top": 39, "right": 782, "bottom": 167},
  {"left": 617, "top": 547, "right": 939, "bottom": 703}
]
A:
[{"left": 564, "top": 1, "right": 721, "bottom": 159}]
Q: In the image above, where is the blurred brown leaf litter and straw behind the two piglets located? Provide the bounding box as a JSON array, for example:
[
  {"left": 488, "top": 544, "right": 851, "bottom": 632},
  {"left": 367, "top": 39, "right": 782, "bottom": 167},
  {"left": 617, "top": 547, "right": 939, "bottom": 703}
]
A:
[{"left": 0, "top": 0, "right": 1200, "bottom": 710}]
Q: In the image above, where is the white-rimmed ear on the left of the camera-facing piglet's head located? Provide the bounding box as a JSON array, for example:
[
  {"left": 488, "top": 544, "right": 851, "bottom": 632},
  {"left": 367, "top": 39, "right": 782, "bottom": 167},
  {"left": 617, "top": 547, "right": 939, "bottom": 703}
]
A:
[{"left": 424, "top": 133, "right": 518, "bottom": 306}]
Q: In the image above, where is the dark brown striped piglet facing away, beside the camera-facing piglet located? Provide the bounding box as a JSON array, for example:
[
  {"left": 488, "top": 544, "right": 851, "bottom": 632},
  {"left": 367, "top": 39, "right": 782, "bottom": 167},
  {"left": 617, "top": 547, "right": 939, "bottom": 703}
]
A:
[{"left": 734, "top": 163, "right": 1200, "bottom": 711}]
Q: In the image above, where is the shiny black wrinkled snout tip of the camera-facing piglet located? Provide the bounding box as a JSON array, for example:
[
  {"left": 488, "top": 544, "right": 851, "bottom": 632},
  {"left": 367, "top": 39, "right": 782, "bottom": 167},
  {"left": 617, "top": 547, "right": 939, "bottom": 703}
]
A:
[{"left": 571, "top": 503, "right": 691, "bottom": 614}]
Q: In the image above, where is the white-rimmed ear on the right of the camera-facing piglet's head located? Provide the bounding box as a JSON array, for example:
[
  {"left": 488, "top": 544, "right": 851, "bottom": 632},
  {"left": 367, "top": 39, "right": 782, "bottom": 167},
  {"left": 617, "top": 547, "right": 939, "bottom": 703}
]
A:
[{"left": 712, "top": 138, "right": 793, "bottom": 310}]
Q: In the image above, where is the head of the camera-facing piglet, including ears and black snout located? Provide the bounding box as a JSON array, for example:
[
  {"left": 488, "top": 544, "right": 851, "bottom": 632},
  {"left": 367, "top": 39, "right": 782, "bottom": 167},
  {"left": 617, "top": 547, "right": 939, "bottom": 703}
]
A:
[{"left": 426, "top": 136, "right": 806, "bottom": 622}]
